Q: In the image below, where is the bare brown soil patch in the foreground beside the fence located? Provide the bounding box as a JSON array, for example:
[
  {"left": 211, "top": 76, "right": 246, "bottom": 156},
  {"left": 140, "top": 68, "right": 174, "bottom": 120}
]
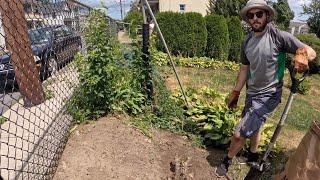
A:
[{"left": 54, "top": 117, "right": 230, "bottom": 180}]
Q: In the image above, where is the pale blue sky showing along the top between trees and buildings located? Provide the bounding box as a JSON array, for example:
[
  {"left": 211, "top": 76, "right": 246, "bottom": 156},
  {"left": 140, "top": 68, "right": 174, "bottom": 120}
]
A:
[{"left": 80, "top": 0, "right": 311, "bottom": 20}]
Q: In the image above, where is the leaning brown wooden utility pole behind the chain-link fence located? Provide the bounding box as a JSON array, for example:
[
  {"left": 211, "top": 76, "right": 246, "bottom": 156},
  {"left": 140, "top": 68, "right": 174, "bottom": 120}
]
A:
[{"left": 0, "top": 0, "right": 44, "bottom": 105}]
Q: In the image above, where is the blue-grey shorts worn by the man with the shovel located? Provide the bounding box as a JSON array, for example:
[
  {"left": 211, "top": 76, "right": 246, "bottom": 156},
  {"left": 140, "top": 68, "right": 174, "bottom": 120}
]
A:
[{"left": 236, "top": 91, "right": 282, "bottom": 138}]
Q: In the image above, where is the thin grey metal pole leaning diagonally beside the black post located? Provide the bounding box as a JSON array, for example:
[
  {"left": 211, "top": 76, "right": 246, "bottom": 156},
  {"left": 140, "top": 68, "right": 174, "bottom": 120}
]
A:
[{"left": 142, "top": 0, "right": 189, "bottom": 108}]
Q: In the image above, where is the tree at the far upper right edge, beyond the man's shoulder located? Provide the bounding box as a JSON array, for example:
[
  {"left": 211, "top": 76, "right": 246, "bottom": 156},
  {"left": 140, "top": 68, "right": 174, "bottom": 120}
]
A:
[{"left": 302, "top": 0, "right": 320, "bottom": 38}]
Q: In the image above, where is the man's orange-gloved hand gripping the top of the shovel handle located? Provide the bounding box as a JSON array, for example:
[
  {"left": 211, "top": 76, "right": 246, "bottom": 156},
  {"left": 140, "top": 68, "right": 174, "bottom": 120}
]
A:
[{"left": 294, "top": 48, "right": 309, "bottom": 73}]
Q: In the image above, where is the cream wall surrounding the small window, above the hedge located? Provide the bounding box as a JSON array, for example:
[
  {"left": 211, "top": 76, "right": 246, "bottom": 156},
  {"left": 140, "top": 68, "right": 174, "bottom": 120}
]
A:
[{"left": 159, "top": 0, "right": 209, "bottom": 16}]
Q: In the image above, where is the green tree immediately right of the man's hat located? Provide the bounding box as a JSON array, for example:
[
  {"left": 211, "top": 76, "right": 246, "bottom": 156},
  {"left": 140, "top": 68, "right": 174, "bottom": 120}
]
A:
[{"left": 272, "top": 0, "right": 294, "bottom": 30}]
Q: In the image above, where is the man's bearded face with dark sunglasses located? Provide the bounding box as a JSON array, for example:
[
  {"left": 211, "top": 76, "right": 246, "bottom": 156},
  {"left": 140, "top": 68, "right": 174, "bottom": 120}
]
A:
[{"left": 247, "top": 9, "right": 267, "bottom": 32}]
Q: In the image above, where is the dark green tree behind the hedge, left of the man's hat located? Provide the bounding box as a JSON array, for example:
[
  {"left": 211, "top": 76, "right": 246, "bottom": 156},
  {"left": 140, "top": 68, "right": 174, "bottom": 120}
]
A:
[{"left": 208, "top": 0, "right": 247, "bottom": 17}]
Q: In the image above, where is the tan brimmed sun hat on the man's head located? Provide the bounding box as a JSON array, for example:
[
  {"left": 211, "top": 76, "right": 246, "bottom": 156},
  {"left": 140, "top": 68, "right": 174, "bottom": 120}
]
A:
[{"left": 240, "top": 0, "right": 275, "bottom": 22}]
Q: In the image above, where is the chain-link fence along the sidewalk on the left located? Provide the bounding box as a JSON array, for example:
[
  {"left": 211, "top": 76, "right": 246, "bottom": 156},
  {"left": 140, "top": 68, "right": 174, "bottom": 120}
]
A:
[{"left": 0, "top": 0, "right": 91, "bottom": 179}]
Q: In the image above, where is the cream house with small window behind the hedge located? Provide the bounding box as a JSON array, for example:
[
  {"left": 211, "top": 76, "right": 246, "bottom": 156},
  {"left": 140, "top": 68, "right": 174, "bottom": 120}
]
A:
[{"left": 141, "top": 0, "right": 209, "bottom": 16}]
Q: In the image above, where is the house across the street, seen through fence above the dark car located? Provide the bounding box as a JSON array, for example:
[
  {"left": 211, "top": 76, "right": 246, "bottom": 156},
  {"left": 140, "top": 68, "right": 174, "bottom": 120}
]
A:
[{"left": 0, "top": 0, "right": 91, "bottom": 49}]
